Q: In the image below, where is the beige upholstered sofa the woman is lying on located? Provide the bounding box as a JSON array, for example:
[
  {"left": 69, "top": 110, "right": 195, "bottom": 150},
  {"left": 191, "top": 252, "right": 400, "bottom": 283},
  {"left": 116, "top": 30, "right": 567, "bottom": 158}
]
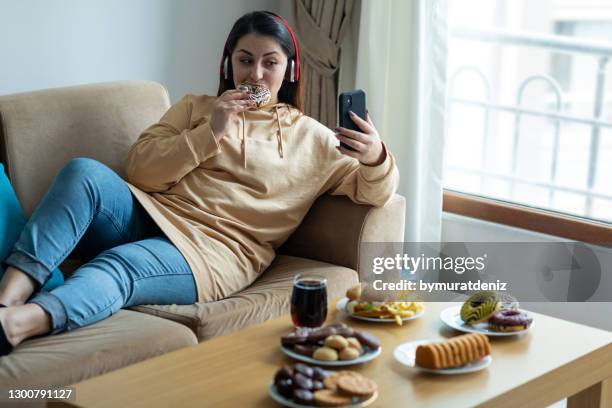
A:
[{"left": 0, "top": 81, "right": 405, "bottom": 386}]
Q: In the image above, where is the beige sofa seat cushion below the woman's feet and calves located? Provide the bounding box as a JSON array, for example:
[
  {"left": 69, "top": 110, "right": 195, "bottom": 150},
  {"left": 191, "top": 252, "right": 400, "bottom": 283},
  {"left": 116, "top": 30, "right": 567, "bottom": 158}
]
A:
[{"left": 0, "top": 310, "right": 197, "bottom": 388}]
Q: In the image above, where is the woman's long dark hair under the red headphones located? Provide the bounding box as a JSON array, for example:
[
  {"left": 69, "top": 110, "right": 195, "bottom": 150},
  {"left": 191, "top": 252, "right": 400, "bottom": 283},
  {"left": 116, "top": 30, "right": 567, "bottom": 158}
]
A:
[{"left": 217, "top": 11, "right": 303, "bottom": 111}]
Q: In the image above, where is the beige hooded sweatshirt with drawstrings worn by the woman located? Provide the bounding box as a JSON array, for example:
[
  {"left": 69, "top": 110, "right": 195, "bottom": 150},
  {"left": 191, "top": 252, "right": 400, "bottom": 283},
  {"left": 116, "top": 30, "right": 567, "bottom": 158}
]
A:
[{"left": 126, "top": 95, "right": 399, "bottom": 302}]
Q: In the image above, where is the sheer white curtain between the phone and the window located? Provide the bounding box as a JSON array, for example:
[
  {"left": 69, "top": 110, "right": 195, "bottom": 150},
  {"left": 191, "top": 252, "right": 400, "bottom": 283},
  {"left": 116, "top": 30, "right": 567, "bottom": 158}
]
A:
[{"left": 355, "top": 0, "right": 447, "bottom": 242}]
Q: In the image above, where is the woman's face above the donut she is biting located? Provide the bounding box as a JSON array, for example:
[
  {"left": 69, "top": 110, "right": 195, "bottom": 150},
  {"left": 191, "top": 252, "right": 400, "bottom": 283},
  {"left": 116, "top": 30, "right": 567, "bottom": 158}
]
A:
[{"left": 232, "top": 33, "right": 287, "bottom": 103}]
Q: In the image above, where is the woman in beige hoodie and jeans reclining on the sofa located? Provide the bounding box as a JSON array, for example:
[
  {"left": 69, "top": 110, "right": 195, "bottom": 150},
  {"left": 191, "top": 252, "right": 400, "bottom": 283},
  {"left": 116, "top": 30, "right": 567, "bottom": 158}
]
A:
[{"left": 0, "top": 8, "right": 398, "bottom": 354}]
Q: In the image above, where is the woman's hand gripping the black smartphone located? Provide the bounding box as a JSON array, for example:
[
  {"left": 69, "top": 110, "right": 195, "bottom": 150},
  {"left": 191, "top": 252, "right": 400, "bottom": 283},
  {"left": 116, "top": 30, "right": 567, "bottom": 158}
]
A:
[{"left": 336, "top": 112, "right": 385, "bottom": 166}]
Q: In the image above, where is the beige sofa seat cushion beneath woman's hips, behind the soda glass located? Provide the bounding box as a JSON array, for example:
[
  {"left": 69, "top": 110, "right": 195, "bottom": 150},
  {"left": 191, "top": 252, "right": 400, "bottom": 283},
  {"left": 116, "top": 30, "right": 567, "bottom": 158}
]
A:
[{"left": 132, "top": 255, "right": 358, "bottom": 341}]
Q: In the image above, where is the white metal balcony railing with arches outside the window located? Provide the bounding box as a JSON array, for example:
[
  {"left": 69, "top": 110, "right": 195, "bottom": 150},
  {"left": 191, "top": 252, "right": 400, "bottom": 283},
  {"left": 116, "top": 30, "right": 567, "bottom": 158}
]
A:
[{"left": 447, "top": 28, "right": 612, "bottom": 217}]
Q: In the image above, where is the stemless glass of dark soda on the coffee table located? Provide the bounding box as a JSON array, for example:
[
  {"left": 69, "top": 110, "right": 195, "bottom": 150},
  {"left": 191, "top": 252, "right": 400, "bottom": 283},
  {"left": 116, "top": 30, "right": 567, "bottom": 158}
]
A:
[{"left": 291, "top": 274, "right": 327, "bottom": 327}]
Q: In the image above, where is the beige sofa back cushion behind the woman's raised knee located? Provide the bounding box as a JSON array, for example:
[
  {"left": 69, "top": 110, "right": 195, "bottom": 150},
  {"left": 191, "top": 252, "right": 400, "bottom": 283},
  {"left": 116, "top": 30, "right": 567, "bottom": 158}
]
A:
[{"left": 0, "top": 81, "right": 170, "bottom": 217}]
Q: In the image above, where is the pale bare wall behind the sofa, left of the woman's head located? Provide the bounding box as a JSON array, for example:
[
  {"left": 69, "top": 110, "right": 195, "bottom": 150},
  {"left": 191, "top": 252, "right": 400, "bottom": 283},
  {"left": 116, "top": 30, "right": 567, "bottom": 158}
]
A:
[{"left": 0, "top": 0, "right": 280, "bottom": 102}]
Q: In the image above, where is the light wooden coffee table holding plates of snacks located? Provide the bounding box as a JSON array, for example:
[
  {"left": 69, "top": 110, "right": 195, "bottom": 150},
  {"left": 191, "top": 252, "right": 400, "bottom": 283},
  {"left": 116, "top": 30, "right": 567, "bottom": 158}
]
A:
[{"left": 69, "top": 303, "right": 612, "bottom": 408}]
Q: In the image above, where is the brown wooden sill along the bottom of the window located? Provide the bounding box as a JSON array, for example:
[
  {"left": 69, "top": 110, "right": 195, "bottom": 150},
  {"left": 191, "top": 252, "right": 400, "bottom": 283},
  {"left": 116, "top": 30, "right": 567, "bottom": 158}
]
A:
[{"left": 443, "top": 190, "right": 612, "bottom": 248}]
